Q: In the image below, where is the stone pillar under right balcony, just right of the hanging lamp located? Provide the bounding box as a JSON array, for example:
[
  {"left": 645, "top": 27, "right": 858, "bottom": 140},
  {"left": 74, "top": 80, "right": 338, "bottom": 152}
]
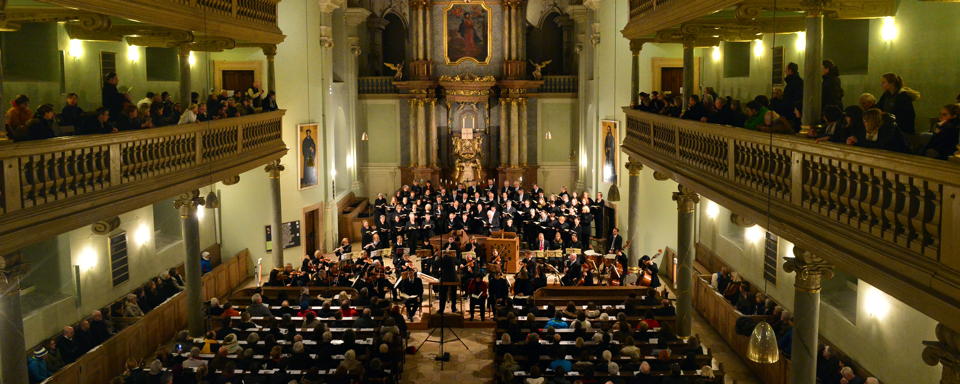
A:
[{"left": 783, "top": 247, "right": 833, "bottom": 384}]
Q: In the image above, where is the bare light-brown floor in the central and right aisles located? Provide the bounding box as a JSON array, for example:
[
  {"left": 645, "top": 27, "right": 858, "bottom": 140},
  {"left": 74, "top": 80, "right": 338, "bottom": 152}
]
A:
[{"left": 401, "top": 313, "right": 761, "bottom": 384}]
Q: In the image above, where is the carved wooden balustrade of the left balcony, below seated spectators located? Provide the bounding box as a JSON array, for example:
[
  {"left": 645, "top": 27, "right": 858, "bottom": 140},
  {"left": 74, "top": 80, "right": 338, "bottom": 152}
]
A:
[{"left": 0, "top": 111, "right": 287, "bottom": 253}]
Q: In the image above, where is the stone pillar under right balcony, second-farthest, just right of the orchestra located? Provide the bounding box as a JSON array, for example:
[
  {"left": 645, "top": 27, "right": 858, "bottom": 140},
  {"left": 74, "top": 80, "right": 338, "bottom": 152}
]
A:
[{"left": 673, "top": 185, "right": 700, "bottom": 338}]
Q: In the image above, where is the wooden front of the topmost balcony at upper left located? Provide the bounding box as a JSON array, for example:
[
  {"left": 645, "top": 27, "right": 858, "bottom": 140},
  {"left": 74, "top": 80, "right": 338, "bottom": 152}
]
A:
[{"left": 40, "top": 0, "right": 284, "bottom": 44}]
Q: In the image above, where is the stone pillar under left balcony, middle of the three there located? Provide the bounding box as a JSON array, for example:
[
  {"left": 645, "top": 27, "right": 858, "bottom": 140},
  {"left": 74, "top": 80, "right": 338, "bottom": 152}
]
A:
[{"left": 173, "top": 189, "right": 207, "bottom": 337}]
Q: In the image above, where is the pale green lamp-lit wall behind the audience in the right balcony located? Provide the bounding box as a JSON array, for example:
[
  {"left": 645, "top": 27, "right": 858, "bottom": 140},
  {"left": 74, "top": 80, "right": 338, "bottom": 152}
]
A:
[{"left": 702, "top": 0, "right": 960, "bottom": 129}]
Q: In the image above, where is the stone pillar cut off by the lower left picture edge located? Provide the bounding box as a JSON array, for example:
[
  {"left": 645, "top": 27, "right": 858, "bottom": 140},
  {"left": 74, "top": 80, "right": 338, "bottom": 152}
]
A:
[{"left": 0, "top": 268, "right": 30, "bottom": 384}]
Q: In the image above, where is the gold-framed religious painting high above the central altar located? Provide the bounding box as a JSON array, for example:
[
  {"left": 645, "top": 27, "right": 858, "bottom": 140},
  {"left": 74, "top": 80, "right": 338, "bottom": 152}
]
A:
[{"left": 443, "top": 1, "right": 493, "bottom": 65}]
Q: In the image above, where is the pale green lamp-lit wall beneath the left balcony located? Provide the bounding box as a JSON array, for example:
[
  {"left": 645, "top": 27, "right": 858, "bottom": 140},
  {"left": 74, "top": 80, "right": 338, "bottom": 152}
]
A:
[{"left": 23, "top": 189, "right": 218, "bottom": 347}]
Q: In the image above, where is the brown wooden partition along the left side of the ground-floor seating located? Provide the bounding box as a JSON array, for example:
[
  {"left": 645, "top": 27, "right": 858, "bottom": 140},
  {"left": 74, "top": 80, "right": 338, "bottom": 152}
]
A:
[{"left": 41, "top": 249, "right": 250, "bottom": 384}]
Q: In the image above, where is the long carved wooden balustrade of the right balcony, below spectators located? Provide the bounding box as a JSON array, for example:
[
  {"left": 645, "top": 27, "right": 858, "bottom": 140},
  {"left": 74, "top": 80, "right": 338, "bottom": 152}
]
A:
[{"left": 623, "top": 108, "right": 960, "bottom": 330}]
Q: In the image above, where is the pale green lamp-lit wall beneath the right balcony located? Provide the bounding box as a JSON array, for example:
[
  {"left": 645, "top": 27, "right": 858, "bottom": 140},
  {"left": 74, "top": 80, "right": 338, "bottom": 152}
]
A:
[{"left": 697, "top": 199, "right": 941, "bottom": 383}]
